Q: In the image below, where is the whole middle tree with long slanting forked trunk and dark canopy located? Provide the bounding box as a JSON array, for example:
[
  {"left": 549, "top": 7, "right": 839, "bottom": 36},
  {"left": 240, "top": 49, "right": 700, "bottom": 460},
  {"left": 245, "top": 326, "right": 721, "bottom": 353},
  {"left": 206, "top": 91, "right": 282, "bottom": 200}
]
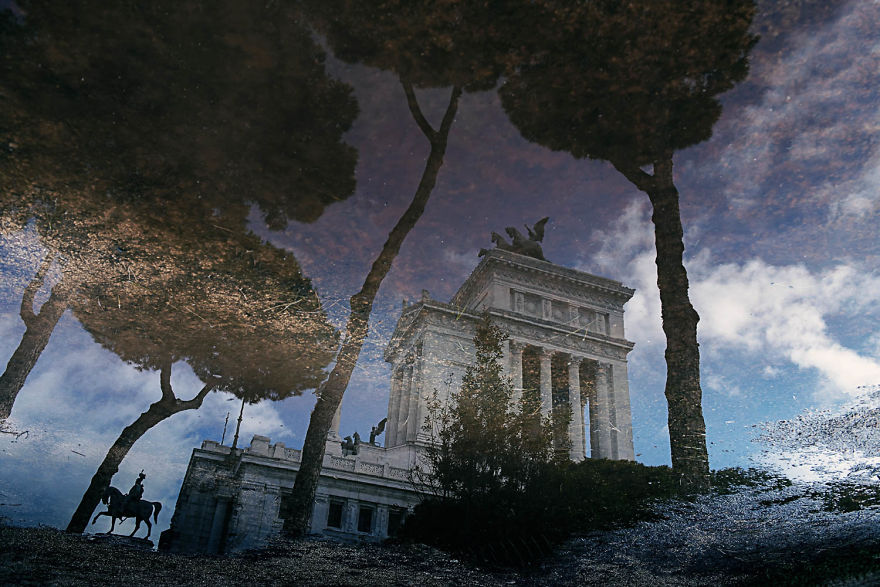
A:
[{"left": 283, "top": 0, "right": 516, "bottom": 535}]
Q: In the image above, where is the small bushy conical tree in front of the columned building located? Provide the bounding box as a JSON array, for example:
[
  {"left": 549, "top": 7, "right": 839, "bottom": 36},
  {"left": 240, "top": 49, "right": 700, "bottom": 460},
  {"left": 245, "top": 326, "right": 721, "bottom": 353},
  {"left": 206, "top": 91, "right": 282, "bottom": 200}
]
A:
[{"left": 422, "top": 317, "right": 552, "bottom": 504}]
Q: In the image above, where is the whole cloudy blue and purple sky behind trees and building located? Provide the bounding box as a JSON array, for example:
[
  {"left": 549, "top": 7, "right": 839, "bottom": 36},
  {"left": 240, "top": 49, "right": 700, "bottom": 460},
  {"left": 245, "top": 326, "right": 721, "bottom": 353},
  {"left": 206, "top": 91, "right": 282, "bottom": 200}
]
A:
[{"left": 0, "top": 1, "right": 880, "bottom": 535}]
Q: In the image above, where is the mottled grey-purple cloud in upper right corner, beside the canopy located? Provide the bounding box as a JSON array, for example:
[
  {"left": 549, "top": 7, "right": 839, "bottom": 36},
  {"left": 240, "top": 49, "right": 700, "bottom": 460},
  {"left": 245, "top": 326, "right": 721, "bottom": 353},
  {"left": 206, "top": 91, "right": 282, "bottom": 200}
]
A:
[{"left": 705, "top": 2, "right": 880, "bottom": 222}]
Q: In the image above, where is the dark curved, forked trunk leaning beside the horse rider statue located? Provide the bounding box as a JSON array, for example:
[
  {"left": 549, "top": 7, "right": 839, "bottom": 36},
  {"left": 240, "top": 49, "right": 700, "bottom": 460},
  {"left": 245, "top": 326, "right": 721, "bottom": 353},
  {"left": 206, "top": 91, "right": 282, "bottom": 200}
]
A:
[{"left": 67, "top": 364, "right": 214, "bottom": 534}]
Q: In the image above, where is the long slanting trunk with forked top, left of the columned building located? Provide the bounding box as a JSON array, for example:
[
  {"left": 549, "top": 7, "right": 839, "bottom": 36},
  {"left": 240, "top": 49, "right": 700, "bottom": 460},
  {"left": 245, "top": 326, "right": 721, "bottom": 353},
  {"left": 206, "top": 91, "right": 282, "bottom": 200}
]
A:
[{"left": 281, "top": 81, "right": 461, "bottom": 536}]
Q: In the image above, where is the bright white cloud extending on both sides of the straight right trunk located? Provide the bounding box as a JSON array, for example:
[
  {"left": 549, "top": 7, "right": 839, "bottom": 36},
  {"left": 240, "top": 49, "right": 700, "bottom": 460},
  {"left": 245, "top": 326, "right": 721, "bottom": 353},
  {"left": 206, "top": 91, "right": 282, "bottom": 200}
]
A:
[{"left": 585, "top": 201, "right": 880, "bottom": 402}]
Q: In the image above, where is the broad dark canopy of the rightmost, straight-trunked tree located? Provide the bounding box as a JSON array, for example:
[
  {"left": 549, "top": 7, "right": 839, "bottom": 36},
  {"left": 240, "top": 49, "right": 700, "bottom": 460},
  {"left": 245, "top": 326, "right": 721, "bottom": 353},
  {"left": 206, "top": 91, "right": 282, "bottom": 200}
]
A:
[{"left": 500, "top": 0, "right": 757, "bottom": 169}]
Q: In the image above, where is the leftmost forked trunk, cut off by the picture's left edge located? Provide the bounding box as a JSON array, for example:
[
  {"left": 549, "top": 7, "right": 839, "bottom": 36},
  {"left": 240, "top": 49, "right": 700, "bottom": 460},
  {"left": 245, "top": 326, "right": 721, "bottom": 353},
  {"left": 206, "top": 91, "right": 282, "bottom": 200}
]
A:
[{"left": 0, "top": 257, "right": 67, "bottom": 420}]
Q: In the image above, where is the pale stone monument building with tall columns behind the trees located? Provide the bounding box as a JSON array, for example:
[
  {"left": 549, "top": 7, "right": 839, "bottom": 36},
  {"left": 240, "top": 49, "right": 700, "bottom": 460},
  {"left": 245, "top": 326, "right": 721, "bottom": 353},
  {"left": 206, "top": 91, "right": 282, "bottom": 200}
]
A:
[{"left": 160, "top": 249, "right": 634, "bottom": 553}]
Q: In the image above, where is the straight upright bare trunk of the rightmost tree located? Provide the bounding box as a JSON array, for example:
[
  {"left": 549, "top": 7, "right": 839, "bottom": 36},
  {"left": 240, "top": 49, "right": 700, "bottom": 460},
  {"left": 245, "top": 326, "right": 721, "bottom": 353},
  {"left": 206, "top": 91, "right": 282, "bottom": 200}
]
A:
[{"left": 645, "top": 155, "right": 709, "bottom": 490}]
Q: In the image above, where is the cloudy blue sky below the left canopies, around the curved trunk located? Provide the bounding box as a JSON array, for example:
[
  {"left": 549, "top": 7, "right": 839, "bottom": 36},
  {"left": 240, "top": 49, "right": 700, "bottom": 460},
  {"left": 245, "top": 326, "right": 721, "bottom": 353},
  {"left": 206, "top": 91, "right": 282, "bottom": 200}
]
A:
[{"left": 0, "top": 315, "right": 293, "bottom": 538}]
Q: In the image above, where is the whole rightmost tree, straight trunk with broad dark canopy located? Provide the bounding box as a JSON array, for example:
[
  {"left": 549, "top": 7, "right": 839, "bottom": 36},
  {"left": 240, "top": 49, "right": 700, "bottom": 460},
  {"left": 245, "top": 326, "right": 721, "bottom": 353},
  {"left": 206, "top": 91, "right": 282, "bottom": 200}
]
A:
[{"left": 500, "top": 0, "right": 756, "bottom": 488}]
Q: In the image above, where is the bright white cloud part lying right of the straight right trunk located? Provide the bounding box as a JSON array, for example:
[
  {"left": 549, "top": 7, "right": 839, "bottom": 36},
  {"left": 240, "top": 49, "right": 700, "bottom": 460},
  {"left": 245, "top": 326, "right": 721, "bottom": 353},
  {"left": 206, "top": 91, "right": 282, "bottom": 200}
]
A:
[{"left": 691, "top": 259, "right": 880, "bottom": 400}]
